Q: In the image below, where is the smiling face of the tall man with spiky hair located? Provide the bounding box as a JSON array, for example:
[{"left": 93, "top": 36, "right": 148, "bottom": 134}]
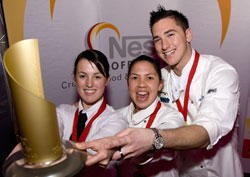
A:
[{"left": 152, "top": 17, "right": 192, "bottom": 75}]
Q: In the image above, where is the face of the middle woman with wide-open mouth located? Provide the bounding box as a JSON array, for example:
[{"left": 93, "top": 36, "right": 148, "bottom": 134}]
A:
[{"left": 128, "top": 61, "right": 163, "bottom": 111}]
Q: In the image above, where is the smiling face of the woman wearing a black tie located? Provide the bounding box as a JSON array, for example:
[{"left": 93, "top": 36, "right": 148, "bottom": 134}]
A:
[{"left": 75, "top": 58, "right": 109, "bottom": 109}]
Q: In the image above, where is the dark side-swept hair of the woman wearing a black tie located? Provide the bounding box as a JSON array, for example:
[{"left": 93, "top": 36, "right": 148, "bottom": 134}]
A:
[{"left": 73, "top": 49, "right": 109, "bottom": 78}]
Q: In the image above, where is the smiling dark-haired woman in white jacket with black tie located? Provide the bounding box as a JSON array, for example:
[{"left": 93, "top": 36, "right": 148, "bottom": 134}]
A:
[{"left": 57, "top": 49, "right": 127, "bottom": 141}]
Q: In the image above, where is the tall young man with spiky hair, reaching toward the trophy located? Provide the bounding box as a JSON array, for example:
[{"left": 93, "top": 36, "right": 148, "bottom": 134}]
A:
[{"left": 79, "top": 6, "right": 243, "bottom": 177}]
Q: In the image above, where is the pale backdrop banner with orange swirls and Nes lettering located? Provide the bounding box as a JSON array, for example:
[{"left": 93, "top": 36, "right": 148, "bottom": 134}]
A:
[{"left": 1, "top": 0, "right": 250, "bottom": 172}]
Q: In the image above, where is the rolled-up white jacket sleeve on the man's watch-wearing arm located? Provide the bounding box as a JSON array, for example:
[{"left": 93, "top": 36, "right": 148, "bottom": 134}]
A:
[{"left": 193, "top": 65, "right": 239, "bottom": 149}]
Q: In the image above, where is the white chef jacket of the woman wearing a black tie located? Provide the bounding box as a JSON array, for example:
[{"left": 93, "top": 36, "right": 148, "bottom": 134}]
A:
[{"left": 56, "top": 99, "right": 128, "bottom": 141}]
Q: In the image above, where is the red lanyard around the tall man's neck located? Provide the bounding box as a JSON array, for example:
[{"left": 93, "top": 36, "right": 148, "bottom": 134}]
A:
[{"left": 176, "top": 51, "right": 200, "bottom": 122}]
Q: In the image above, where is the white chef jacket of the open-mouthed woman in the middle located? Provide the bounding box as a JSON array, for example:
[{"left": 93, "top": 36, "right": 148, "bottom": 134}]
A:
[{"left": 117, "top": 97, "right": 185, "bottom": 177}]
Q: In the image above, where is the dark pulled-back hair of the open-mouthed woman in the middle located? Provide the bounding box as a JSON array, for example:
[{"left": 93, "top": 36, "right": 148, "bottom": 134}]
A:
[{"left": 128, "top": 55, "right": 162, "bottom": 80}]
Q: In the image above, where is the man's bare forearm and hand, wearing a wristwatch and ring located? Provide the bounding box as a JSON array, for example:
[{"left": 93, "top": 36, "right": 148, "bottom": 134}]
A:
[{"left": 113, "top": 125, "right": 210, "bottom": 159}]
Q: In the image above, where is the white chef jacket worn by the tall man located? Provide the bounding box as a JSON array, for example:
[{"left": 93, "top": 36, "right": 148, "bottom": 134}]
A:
[{"left": 161, "top": 50, "right": 243, "bottom": 177}]
